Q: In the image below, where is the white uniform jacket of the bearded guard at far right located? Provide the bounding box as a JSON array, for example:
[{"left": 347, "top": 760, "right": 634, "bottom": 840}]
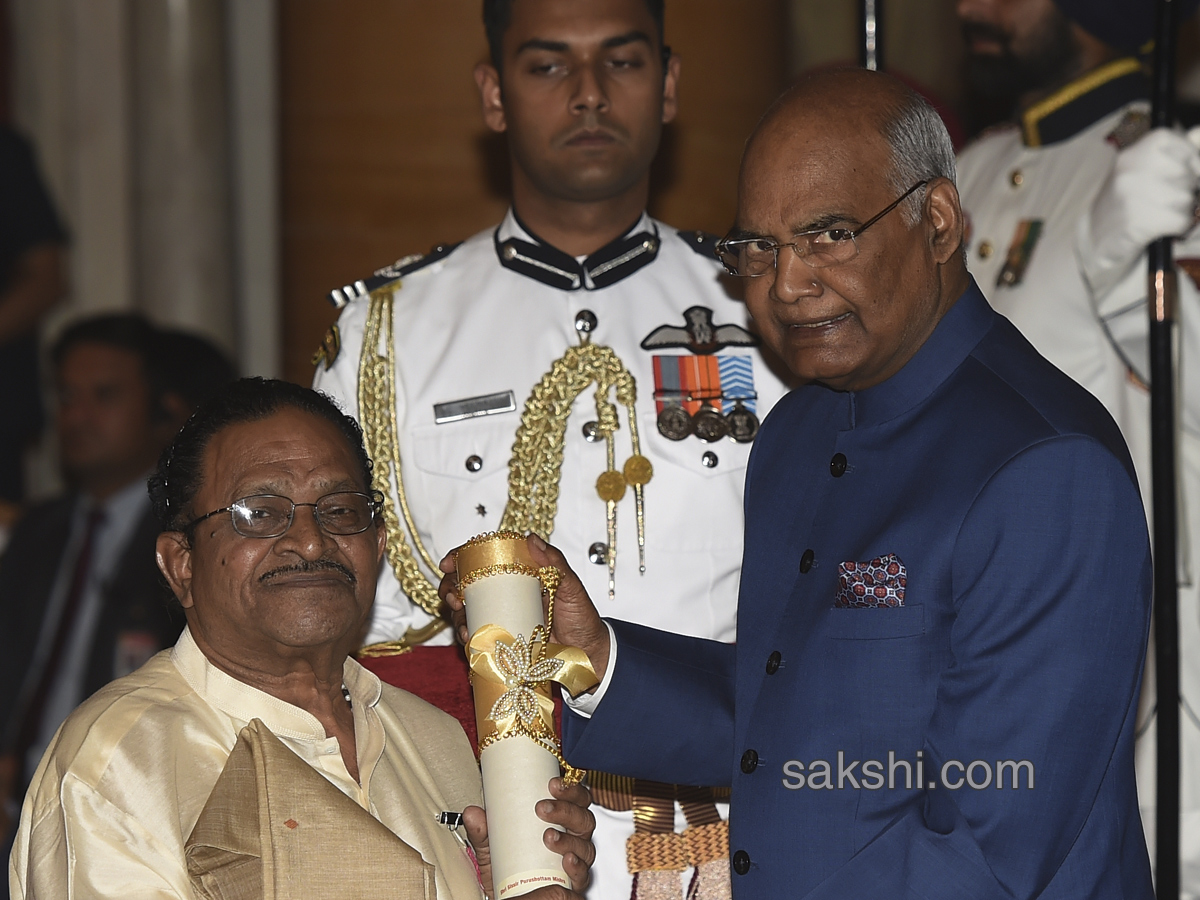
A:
[{"left": 959, "top": 59, "right": 1200, "bottom": 896}]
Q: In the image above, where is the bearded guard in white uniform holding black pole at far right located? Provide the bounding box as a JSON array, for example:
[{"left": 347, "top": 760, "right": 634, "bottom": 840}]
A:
[{"left": 958, "top": 0, "right": 1200, "bottom": 898}]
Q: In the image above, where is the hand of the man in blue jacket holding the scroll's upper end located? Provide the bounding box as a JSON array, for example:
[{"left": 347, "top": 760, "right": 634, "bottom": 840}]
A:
[{"left": 438, "top": 534, "right": 608, "bottom": 690}]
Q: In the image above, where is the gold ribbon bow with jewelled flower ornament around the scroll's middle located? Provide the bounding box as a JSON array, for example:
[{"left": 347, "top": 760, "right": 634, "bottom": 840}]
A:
[{"left": 467, "top": 625, "right": 599, "bottom": 784}]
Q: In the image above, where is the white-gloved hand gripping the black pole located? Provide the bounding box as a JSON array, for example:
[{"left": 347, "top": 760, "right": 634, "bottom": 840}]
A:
[{"left": 1078, "top": 128, "right": 1200, "bottom": 293}]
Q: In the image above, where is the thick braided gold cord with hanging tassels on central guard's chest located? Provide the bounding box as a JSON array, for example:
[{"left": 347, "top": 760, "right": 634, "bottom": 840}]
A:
[{"left": 500, "top": 338, "right": 654, "bottom": 600}]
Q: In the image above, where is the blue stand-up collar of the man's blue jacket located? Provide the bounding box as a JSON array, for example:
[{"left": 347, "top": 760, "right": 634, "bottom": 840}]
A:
[{"left": 845, "top": 278, "right": 996, "bottom": 428}]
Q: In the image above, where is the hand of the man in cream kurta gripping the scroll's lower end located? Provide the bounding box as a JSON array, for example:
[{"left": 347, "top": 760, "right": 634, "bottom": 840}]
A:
[{"left": 462, "top": 778, "right": 596, "bottom": 900}]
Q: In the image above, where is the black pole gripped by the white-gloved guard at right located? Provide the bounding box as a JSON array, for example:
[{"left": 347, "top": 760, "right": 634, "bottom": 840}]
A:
[{"left": 1148, "top": 0, "right": 1180, "bottom": 900}]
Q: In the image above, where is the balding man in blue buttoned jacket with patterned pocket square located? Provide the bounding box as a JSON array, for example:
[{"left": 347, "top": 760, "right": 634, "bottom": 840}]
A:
[{"left": 443, "top": 71, "right": 1152, "bottom": 900}]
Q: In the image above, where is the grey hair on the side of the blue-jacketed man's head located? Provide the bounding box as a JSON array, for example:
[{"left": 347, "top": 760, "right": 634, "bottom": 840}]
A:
[{"left": 882, "top": 91, "right": 955, "bottom": 228}]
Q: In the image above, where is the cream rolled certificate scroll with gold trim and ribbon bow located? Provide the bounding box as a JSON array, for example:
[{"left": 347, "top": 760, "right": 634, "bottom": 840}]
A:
[{"left": 457, "top": 532, "right": 596, "bottom": 900}]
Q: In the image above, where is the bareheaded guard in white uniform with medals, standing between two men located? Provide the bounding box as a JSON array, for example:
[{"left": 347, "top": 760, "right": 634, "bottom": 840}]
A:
[{"left": 314, "top": 0, "right": 787, "bottom": 900}]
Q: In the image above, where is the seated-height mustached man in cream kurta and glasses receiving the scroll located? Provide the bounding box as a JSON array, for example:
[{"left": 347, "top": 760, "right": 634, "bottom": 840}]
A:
[{"left": 10, "top": 379, "right": 594, "bottom": 900}]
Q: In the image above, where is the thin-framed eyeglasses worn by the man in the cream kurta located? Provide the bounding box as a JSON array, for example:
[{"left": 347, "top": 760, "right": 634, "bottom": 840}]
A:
[{"left": 181, "top": 491, "right": 383, "bottom": 538}]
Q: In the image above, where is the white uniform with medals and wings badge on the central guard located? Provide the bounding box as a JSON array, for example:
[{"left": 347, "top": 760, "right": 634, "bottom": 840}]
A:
[{"left": 313, "top": 211, "right": 787, "bottom": 900}]
